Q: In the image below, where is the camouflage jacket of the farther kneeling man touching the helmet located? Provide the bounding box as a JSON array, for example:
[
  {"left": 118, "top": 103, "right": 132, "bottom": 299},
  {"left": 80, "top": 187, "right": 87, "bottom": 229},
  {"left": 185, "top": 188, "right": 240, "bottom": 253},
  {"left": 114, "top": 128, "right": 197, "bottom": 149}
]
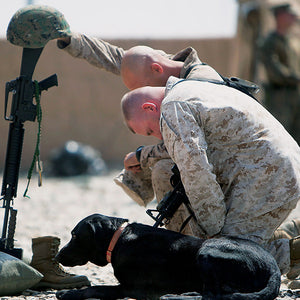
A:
[{"left": 57, "top": 33, "right": 222, "bottom": 168}]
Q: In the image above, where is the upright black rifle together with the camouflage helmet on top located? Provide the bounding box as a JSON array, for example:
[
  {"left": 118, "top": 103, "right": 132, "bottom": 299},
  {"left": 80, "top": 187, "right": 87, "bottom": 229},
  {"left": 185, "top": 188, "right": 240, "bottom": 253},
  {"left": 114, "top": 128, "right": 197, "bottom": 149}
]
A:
[{"left": 0, "top": 5, "right": 70, "bottom": 258}]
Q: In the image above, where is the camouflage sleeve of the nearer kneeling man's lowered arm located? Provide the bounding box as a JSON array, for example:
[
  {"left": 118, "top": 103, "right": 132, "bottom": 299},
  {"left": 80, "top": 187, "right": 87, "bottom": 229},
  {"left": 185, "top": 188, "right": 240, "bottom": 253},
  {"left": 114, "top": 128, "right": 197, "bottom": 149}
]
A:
[{"left": 161, "top": 102, "right": 226, "bottom": 237}]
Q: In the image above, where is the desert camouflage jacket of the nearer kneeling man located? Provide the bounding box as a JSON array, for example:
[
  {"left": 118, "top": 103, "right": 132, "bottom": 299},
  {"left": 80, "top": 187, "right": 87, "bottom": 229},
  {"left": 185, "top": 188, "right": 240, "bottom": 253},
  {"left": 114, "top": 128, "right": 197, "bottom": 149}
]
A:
[{"left": 161, "top": 77, "right": 300, "bottom": 236}]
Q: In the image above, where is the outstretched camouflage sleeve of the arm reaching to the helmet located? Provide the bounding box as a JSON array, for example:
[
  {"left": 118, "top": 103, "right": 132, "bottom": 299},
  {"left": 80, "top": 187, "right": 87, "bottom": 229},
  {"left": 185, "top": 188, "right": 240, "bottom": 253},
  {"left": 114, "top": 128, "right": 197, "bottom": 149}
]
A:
[{"left": 57, "top": 33, "right": 125, "bottom": 75}]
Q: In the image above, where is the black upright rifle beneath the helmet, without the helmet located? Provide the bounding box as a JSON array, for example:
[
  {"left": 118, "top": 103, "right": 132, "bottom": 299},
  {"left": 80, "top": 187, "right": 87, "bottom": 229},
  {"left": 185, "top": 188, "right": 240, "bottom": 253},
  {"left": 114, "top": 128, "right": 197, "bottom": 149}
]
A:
[{"left": 0, "top": 47, "right": 58, "bottom": 258}]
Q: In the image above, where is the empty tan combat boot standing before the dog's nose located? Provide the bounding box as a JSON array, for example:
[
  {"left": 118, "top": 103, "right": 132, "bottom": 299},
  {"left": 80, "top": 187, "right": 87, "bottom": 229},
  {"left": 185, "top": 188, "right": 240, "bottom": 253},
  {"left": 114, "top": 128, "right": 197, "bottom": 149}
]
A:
[{"left": 30, "top": 236, "right": 91, "bottom": 290}]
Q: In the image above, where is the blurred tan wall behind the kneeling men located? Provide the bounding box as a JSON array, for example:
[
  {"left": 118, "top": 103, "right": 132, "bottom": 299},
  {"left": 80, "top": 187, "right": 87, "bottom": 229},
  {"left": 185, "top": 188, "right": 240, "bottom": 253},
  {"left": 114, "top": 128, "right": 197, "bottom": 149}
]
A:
[{"left": 0, "top": 39, "right": 236, "bottom": 168}]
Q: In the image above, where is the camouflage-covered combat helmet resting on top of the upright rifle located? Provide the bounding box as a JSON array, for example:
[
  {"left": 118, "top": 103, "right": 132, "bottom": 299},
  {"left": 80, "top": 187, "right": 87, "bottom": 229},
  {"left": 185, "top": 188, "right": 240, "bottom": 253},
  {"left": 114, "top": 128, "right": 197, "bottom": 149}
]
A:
[{"left": 6, "top": 5, "right": 71, "bottom": 48}]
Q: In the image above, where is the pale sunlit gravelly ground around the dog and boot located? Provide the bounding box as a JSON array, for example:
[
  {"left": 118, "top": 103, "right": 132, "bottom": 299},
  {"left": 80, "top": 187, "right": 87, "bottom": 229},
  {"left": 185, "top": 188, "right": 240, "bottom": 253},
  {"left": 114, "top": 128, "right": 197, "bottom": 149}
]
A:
[{"left": 0, "top": 170, "right": 300, "bottom": 300}]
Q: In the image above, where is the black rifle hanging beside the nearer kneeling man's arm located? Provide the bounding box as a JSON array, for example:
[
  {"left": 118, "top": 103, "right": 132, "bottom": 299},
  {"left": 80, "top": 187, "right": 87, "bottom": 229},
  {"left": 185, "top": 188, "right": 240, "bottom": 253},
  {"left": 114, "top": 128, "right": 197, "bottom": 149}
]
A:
[{"left": 146, "top": 164, "right": 195, "bottom": 232}]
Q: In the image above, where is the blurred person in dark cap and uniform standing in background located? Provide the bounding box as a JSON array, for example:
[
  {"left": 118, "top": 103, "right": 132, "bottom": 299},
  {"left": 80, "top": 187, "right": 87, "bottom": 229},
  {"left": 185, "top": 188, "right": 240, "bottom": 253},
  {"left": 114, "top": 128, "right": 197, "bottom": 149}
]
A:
[{"left": 260, "top": 1, "right": 300, "bottom": 144}]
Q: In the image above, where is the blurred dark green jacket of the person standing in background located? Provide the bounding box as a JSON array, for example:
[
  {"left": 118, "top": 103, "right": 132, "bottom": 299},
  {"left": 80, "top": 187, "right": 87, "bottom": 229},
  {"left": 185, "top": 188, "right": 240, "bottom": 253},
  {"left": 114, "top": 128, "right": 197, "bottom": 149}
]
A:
[{"left": 260, "top": 32, "right": 300, "bottom": 86}]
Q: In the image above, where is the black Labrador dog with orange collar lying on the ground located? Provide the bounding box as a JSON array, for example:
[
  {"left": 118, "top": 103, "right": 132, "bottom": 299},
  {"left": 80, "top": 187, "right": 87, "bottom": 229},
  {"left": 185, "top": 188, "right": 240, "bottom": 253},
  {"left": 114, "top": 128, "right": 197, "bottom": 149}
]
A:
[{"left": 56, "top": 214, "right": 281, "bottom": 300}]
